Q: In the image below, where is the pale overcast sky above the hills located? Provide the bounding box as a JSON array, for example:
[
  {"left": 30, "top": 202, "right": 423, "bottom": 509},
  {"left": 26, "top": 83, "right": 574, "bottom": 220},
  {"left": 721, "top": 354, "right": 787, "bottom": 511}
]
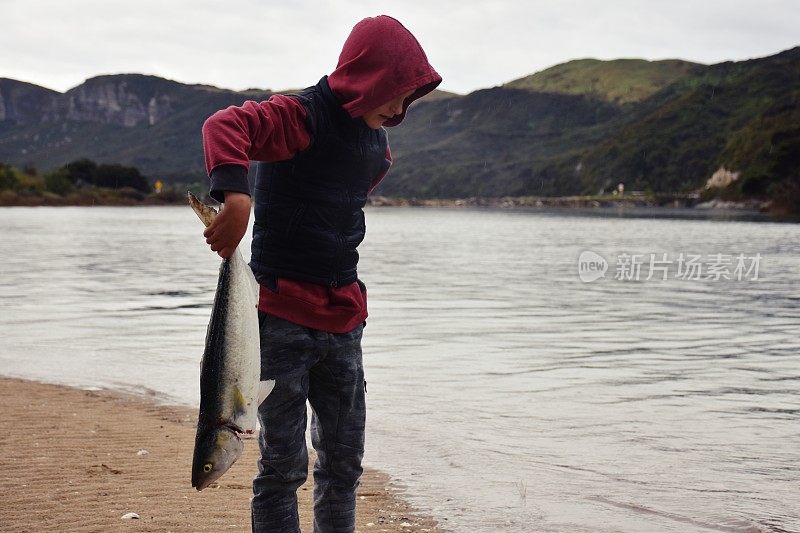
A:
[{"left": 0, "top": 0, "right": 800, "bottom": 93}]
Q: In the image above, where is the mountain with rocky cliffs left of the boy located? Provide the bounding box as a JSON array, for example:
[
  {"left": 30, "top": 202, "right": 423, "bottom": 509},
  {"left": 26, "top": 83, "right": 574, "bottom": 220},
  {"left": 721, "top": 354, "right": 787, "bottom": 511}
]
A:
[{"left": 0, "top": 74, "right": 272, "bottom": 181}]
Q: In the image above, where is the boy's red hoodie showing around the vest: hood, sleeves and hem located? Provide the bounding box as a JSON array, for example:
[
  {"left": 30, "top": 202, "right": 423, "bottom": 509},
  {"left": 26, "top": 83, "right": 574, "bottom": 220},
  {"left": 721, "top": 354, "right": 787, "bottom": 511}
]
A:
[{"left": 203, "top": 15, "right": 442, "bottom": 333}]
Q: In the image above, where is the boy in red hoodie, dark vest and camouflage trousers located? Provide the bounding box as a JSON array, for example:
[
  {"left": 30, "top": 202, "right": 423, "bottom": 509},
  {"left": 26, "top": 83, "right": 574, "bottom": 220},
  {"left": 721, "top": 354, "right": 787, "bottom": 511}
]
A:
[{"left": 198, "top": 16, "right": 441, "bottom": 533}]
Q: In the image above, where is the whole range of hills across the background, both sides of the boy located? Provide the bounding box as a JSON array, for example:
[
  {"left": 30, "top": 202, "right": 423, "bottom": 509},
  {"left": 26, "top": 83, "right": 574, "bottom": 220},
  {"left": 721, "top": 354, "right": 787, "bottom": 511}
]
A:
[{"left": 0, "top": 47, "right": 800, "bottom": 206}]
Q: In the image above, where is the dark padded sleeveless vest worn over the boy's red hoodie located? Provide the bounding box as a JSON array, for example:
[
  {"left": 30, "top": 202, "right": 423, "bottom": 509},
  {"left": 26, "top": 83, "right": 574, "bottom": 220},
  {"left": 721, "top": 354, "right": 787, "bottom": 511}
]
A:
[{"left": 250, "top": 77, "right": 389, "bottom": 287}]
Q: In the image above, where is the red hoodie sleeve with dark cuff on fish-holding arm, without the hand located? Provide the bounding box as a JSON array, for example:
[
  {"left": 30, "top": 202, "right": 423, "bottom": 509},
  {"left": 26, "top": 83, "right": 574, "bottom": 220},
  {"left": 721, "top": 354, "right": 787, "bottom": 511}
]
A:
[{"left": 203, "top": 95, "right": 311, "bottom": 202}]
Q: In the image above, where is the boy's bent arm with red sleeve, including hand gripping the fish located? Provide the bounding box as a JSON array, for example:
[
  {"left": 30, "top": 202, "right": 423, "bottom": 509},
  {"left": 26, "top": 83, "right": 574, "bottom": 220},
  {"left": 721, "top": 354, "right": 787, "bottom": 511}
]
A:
[{"left": 203, "top": 95, "right": 310, "bottom": 257}]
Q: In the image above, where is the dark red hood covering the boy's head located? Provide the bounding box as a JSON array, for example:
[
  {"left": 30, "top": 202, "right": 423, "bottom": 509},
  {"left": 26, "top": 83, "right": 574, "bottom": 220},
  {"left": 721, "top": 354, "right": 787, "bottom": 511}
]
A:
[{"left": 328, "top": 15, "right": 442, "bottom": 126}]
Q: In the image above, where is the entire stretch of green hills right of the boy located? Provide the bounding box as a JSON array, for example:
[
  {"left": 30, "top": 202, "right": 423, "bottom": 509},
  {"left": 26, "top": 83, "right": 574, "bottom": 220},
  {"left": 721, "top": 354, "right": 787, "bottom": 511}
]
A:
[{"left": 379, "top": 47, "right": 800, "bottom": 202}]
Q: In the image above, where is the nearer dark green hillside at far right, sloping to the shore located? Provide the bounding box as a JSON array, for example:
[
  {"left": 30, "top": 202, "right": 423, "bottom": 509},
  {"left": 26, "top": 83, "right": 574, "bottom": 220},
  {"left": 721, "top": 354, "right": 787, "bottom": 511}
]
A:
[{"left": 581, "top": 48, "right": 800, "bottom": 193}]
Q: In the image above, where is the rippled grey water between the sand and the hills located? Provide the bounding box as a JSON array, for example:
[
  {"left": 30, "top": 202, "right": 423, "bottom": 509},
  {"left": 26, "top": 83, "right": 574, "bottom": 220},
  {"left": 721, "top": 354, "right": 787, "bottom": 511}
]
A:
[{"left": 0, "top": 207, "right": 800, "bottom": 532}]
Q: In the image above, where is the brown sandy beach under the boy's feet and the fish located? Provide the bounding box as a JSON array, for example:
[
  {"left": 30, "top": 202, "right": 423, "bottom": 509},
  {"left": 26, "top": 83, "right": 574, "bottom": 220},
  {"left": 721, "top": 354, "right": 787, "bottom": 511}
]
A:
[{"left": 0, "top": 378, "right": 443, "bottom": 532}]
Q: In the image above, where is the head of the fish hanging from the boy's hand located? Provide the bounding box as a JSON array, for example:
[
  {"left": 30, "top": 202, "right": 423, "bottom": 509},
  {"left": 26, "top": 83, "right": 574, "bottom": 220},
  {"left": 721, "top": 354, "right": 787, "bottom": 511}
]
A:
[{"left": 192, "top": 426, "right": 244, "bottom": 490}]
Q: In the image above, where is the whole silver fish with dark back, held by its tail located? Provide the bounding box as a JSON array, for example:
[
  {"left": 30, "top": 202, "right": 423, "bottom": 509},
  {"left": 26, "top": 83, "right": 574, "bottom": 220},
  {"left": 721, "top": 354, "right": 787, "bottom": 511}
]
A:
[{"left": 188, "top": 192, "right": 275, "bottom": 491}]
